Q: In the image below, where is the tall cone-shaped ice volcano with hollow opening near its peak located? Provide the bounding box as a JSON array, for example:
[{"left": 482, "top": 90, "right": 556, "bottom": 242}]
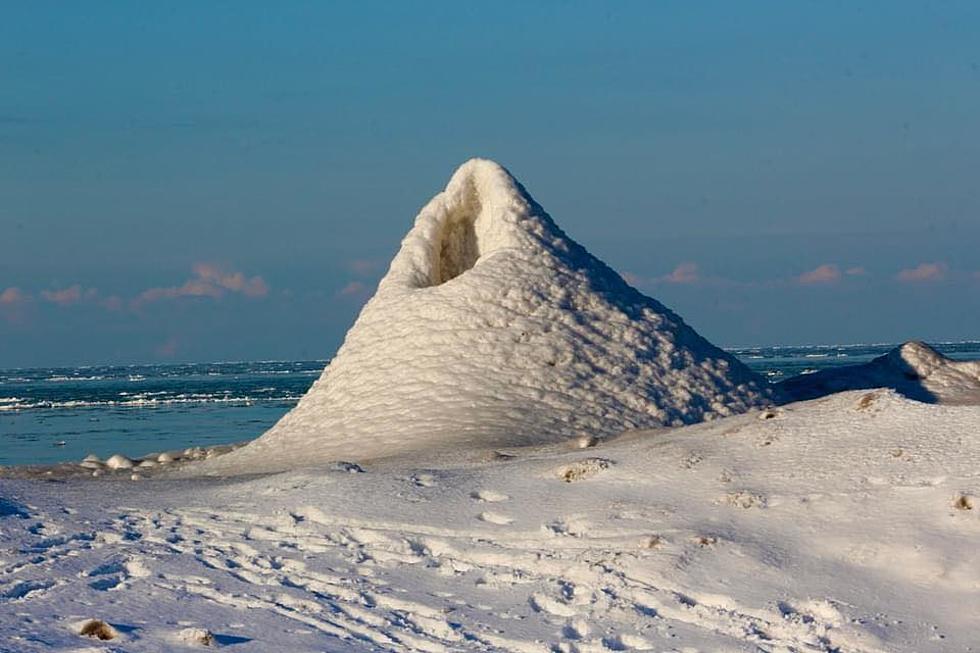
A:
[{"left": 213, "top": 159, "right": 769, "bottom": 470}]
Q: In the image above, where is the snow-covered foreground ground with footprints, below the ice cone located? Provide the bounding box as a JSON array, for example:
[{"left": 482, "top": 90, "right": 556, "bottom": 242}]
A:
[{"left": 0, "top": 390, "right": 980, "bottom": 653}]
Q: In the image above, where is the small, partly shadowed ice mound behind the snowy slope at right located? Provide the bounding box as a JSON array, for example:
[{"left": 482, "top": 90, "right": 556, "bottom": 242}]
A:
[{"left": 776, "top": 342, "right": 980, "bottom": 404}]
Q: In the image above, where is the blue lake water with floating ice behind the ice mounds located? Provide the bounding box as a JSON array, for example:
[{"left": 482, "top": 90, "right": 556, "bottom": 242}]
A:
[{"left": 0, "top": 342, "right": 980, "bottom": 465}]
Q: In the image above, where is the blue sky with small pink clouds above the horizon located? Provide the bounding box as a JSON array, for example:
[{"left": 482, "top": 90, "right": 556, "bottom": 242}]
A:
[{"left": 0, "top": 1, "right": 980, "bottom": 367}]
